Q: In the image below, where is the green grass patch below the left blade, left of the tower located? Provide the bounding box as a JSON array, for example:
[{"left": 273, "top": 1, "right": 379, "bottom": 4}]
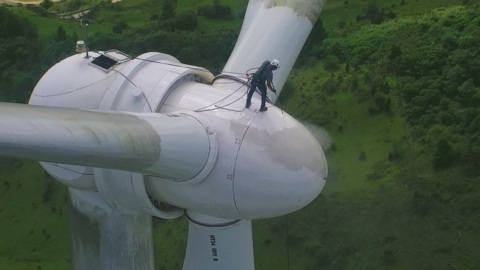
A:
[{"left": 0, "top": 159, "right": 70, "bottom": 270}]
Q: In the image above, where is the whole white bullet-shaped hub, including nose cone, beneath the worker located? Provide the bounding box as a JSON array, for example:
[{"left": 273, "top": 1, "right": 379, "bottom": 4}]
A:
[{"left": 149, "top": 79, "right": 328, "bottom": 219}]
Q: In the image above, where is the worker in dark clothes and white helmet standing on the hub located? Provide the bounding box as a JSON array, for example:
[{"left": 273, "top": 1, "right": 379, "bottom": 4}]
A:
[{"left": 246, "top": 60, "right": 280, "bottom": 112}]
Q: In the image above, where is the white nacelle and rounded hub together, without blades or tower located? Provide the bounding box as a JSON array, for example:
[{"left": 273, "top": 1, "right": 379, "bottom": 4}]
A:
[{"left": 24, "top": 49, "right": 327, "bottom": 219}]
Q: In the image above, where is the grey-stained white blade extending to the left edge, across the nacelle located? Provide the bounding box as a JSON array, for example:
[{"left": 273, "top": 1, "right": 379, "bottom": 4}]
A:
[{"left": 0, "top": 103, "right": 210, "bottom": 182}]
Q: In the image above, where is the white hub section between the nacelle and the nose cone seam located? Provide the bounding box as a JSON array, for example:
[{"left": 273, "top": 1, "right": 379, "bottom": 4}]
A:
[{"left": 148, "top": 83, "right": 257, "bottom": 219}]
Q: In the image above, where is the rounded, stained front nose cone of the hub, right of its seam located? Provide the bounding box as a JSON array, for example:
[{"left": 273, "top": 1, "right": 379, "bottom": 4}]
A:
[{"left": 234, "top": 107, "right": 328, "bottom": 219}]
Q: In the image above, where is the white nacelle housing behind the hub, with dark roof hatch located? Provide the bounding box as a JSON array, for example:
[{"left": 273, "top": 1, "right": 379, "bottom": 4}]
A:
[{"left": 30, "top": 51, "right": 216, "bottom": 218}]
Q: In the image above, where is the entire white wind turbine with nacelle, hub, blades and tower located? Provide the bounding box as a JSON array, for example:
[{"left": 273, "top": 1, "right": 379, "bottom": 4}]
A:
[{"left": 0, "top": 0, "right": 328, "bottom": 270}]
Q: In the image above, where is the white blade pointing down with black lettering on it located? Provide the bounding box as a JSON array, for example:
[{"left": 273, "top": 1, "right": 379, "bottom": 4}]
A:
[{"left": 183, "top": 216, "right": 255, "bottom": 270}]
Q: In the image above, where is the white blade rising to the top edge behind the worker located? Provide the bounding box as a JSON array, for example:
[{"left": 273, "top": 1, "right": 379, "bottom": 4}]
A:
[{"left": 218, "top": 0, "right": 326, "bottom": 102}]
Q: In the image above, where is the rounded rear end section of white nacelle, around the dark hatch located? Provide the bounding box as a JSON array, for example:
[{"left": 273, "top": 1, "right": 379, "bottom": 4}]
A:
[{"left": 29, "top": 52, "right": 126, "bottom": 191}]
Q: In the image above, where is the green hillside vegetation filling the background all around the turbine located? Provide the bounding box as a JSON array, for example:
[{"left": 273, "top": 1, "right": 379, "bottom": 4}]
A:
[{"left": 0, "top": 0, "right": 480, "bottom": 270}]
